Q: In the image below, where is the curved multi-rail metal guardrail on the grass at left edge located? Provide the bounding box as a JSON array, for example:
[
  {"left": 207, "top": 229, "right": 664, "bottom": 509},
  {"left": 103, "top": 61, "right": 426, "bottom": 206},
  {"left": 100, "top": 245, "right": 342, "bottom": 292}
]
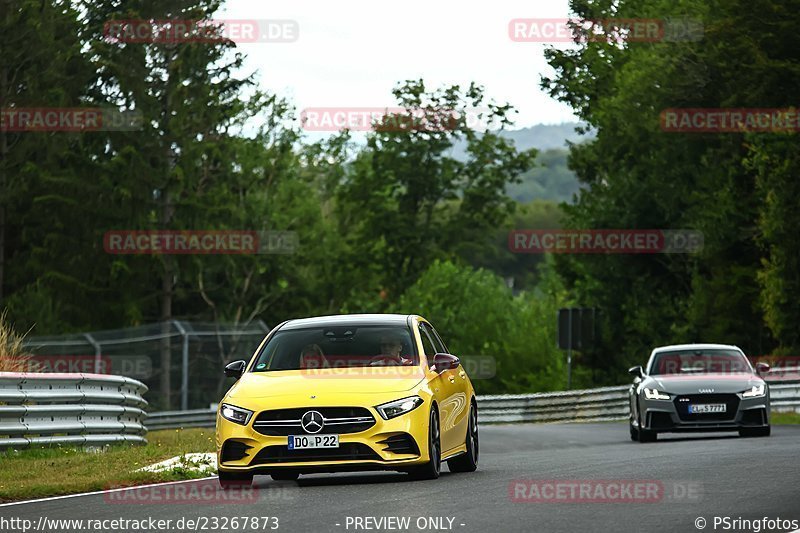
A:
[{"left": 0, "top": 372, "right": 147, "bottom": 449}]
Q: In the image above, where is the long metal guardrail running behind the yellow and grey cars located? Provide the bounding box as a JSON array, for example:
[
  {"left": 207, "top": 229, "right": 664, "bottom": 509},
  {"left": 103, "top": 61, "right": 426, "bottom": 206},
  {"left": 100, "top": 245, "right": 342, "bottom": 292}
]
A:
[{"left": 147, "top": 380, "right": 800, "bottom": 430}]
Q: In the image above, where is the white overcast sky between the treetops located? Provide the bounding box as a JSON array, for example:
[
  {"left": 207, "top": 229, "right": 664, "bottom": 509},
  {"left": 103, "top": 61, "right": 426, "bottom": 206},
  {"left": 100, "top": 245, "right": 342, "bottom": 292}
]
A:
[{"left": 218, "top": 0, "right": 575, "bottom": 127}]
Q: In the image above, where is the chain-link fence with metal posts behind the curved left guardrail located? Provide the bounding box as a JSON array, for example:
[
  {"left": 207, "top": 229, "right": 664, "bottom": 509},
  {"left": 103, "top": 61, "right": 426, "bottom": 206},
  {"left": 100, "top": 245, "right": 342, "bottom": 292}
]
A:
[{"left": 24, "top": 320, "right": 269, "bottom": 411}]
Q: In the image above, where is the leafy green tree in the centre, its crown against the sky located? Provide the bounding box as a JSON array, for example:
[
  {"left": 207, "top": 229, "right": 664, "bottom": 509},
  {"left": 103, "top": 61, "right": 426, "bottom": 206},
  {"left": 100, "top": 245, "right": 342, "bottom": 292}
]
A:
[{"left": 337, "top": 80, "right": 535, "bottom": 302}]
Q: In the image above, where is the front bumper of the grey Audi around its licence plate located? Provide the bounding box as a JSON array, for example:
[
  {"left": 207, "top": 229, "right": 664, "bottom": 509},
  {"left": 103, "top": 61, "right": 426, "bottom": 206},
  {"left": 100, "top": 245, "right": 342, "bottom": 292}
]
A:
[{"left": 639, "top": 393, "right": 770, "bottom": 433}]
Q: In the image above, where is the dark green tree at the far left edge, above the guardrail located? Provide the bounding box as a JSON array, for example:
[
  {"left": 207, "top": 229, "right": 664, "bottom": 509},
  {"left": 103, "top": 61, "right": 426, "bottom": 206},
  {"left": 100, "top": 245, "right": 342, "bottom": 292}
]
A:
[{"left": 0, "top": 0, "right": 93, "bottom": 329}]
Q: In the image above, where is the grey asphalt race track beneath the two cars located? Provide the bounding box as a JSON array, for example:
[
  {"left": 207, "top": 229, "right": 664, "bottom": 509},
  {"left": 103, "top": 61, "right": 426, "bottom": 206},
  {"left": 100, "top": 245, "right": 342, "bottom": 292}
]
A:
[{"left": 0, "top": 423, "right": 800, "bottom": 533}]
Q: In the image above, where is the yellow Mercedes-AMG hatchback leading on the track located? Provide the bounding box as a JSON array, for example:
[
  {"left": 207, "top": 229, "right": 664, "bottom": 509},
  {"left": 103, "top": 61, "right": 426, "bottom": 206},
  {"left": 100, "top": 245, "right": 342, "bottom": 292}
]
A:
[{"left": 217, "top": 315, "right": 478, "bottom": 487}]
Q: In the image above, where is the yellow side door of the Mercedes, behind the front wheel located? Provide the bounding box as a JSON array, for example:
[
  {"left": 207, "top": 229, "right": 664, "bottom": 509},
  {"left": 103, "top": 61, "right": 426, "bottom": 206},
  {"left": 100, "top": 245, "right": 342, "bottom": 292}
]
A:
[{"left": 419, "top": 321, "right": 469, "bottom": 453}]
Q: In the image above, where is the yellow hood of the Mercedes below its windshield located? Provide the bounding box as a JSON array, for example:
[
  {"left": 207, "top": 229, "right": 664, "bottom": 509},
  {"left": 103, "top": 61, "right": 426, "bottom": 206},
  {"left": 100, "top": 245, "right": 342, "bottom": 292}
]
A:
[{"left": 222, "top": 366, "right": 425, "bottom": 399}]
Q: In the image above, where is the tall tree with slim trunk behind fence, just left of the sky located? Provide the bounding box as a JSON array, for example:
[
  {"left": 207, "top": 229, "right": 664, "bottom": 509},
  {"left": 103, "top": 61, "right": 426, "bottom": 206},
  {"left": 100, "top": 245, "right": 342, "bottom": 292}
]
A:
[{"left": 79, "top": 0, "right": 274, "bottom": 408}]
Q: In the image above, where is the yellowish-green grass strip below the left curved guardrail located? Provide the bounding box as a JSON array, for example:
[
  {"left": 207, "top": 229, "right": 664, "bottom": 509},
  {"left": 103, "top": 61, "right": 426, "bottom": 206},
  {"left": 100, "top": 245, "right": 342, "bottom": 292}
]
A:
[{"left": 0, "top": 429, "right": 214, "bottom": 503}]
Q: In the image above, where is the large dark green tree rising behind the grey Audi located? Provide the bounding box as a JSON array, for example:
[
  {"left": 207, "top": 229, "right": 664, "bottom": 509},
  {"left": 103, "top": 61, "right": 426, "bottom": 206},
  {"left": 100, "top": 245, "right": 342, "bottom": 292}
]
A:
[{"left": 543, "top": 0, "right": 800, "bottom": 382}]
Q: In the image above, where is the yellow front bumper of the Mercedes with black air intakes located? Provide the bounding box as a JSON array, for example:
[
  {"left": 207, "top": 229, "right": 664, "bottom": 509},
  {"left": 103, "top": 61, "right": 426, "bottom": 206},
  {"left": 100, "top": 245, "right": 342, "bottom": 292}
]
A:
[{"left": 216, "top": 402, "right": 430, "bottom": 474}]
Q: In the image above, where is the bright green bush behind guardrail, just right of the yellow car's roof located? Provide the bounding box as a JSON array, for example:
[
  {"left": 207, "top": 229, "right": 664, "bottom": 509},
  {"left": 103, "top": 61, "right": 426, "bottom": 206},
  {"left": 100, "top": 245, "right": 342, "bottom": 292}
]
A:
[{"left": 393, "top": 261, "right": 566, "bottom": 394}]
